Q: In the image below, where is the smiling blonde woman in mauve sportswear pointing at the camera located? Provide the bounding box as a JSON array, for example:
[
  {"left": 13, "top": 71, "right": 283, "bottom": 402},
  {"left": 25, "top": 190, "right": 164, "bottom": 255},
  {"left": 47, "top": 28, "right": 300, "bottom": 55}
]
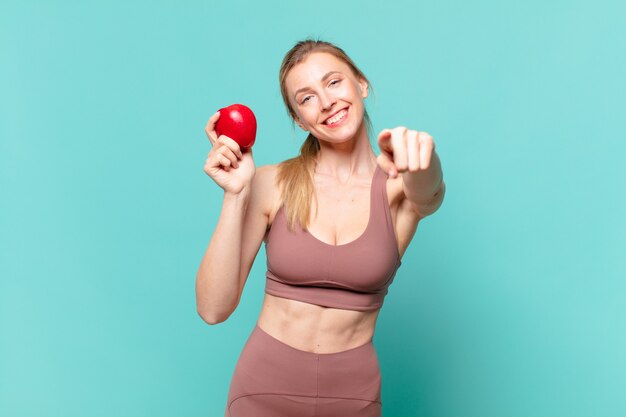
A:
[{"left": 196, "top": 40, "right": 445, "bottom": 417}]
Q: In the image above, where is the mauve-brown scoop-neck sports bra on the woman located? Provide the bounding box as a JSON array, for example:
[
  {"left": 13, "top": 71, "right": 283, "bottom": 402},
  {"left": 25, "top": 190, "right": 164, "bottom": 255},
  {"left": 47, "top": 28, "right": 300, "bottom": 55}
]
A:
[{"left": 265, "top": 165, "right": 402, "bottom": 311}]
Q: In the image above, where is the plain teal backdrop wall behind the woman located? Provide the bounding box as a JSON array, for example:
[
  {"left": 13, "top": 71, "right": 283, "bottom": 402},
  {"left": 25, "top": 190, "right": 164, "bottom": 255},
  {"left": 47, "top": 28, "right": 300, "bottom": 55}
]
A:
[{"left": 0, "top": 0, "right": 626, "bottom": 417}]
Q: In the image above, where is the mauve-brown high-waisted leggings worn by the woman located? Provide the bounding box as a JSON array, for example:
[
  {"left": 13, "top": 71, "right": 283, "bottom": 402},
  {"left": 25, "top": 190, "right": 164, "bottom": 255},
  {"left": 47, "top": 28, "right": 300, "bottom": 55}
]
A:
[{"left": 224, "top": 324, "right": 382, "bottom": 417}]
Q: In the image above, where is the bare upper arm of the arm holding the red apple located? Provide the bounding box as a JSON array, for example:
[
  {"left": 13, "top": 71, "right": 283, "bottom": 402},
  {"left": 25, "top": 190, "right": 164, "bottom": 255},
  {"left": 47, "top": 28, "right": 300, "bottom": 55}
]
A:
[{"left": 237, "top": 165, "right": 274, "bottom": 304}]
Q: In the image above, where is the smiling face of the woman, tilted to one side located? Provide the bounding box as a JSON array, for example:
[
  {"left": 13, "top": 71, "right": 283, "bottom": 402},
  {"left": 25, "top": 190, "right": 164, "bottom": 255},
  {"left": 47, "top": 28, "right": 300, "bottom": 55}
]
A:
[{"left": 285, "top": 52, "right": 368, "bottom": 142}]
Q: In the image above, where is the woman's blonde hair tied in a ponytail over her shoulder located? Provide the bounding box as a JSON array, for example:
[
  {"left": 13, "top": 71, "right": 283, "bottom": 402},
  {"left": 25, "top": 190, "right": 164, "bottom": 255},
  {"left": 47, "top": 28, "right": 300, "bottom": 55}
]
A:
[{"left": 276, "top": 39, "right": 372, "bottom": 231}]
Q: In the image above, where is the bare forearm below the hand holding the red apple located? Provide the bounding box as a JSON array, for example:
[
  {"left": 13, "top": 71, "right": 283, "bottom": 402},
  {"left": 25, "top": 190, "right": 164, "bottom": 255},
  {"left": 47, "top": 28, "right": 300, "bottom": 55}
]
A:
[{"left": 196, "top": 192, "right": 249, "bottom": 324}]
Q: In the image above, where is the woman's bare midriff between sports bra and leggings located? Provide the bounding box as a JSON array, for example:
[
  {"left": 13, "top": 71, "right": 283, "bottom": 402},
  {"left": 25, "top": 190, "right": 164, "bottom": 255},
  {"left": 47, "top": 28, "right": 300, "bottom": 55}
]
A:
[{"left": 257, "top": 293, "right": 380, "bottom": 353}]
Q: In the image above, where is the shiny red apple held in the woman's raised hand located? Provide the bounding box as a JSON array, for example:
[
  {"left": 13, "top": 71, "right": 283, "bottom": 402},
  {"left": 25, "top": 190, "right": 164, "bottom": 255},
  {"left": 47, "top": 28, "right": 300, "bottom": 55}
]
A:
[{"left": 215, "top": 104, "right": 256, "bottom": 151}]
